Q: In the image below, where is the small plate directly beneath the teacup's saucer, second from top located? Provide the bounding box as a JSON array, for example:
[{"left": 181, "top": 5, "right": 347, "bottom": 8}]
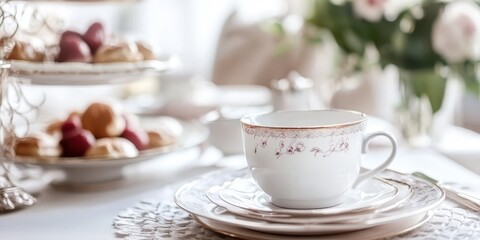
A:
[{"left": 206, "top": 181, "right": 411, "bottom": 224}]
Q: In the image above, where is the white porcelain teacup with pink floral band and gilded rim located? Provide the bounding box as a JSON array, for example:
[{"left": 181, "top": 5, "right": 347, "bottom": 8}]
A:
[{"left": 241, "top": 110, "right": 397, "bottom": 208}]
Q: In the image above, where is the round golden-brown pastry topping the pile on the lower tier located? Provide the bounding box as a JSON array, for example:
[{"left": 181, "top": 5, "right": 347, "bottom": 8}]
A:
[{"left": 81, "top": 103, "right": 126, "bottom": 138}]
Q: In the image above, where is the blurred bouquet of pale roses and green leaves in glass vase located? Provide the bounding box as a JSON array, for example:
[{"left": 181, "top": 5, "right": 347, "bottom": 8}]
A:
[{"left": 306, "top": 0, "right": 480, "bottom": 145}]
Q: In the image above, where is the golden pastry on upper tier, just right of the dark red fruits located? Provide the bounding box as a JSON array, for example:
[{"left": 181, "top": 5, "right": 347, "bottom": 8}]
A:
[{"left": 93, "top": 43, "right": 143, "bottom": 63}]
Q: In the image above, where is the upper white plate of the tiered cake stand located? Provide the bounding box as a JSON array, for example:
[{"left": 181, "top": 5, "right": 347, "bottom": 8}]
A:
[{"left": 9, "top": 56, "right": 180, "bottom": 85}]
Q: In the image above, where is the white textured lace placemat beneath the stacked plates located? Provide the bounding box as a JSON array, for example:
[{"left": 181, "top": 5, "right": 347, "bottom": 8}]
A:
[{"left": 113, "top": 185, "right": 480, "bottom": 240}]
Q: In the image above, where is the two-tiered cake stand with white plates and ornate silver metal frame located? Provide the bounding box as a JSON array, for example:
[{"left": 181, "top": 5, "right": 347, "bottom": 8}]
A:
[{"left": 0, "top": 0, "right": 204, "bottom": 213}]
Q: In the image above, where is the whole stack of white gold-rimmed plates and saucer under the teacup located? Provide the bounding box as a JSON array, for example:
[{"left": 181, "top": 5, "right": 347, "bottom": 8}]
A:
[{"left": 175, "top": 169, "right": 445, "bottom": 239}]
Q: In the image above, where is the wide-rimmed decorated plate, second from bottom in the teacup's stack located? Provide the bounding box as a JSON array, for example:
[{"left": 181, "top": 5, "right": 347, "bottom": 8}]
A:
[{"left": 175, "top": 169, "right": 445, "bottom": 235}]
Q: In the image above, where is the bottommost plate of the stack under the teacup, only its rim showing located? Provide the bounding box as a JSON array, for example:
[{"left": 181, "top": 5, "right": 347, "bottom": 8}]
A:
[{"left": 194, "top": 211, "right": 433, "bottom": 240}]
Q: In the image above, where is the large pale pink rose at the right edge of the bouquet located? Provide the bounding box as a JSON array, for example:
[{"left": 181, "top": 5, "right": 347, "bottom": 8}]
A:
[{"left": 432, "top": 1, "right": 480, "bottom": 63}]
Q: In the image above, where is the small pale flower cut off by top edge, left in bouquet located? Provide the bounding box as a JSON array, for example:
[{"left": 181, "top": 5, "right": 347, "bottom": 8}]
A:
[{"left": 352, "top": 0, "right": 387, "bottom": 22}]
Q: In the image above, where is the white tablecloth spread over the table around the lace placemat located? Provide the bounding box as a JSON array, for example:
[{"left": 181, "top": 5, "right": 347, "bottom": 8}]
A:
[{"left": 0, "top": 139, "right": 480, "bottom": 240}]
